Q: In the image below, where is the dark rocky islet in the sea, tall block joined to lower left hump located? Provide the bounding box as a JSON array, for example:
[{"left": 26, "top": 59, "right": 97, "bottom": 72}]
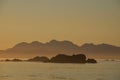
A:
[{"left": 27, "top": 54, "right": 97, "bottom": 63}]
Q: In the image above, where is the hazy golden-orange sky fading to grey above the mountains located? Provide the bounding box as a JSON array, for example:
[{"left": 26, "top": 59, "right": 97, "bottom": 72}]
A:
[{"left": 0, "top": 0, "right": 120, "bottom": 50}]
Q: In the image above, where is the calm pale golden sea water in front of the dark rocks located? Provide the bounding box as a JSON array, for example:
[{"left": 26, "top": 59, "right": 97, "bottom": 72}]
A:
[{"left": 0, "top": 61, "right": 120, "bottom": 80}]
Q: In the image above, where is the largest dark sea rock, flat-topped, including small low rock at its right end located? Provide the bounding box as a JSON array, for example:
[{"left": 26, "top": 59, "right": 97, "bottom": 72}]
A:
[{"left": 50, "top": 54, "right": 97, "bottom": 63}]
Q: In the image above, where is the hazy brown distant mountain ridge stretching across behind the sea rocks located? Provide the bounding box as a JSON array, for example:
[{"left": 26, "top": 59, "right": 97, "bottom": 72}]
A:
[{"left": 0, "top": 40, "right": 120, "bottom": 58}]
